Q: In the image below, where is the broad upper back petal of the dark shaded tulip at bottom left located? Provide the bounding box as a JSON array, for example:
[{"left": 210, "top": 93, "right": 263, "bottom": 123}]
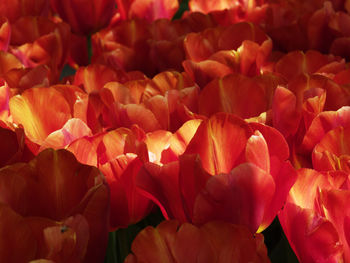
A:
[{"left": 0, "top": 149, "right": 102, "bottom": 220}]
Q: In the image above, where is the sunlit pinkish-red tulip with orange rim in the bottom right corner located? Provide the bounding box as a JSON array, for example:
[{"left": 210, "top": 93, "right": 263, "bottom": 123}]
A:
[{"left": 279, "top": 169, "right": 350, "bottom": 263}]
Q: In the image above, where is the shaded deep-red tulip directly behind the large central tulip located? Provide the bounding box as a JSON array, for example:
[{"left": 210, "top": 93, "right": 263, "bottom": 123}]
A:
[{"left": 198, "top": 73, "right": 284, "bottom": 118}]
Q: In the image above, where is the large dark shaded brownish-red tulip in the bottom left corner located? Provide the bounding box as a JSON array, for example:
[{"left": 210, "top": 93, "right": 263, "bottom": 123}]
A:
[{"left": 0, "top": 150, "right": 109, "bottom": 262}]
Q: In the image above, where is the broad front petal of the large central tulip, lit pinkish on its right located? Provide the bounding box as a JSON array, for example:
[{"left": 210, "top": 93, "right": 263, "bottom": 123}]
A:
[{"left": 193, "top": 163, "right": 275, "bottom": 233}]
